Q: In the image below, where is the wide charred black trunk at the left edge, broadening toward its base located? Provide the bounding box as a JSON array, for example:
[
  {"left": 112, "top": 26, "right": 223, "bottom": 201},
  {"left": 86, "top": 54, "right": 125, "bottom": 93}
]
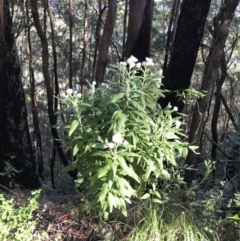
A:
[{"left": 0, "top": 0, "right": 40, "bottom": 188}]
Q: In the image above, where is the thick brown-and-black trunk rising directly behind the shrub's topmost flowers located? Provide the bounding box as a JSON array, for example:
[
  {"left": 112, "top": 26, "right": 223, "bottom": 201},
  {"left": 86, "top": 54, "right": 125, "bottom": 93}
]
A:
[{"left": 125, "top": 0, "right": 153, "bottom": 62}]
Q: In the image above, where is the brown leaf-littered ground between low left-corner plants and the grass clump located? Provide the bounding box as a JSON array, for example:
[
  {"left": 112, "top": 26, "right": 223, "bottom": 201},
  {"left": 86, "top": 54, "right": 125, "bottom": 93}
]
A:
[{"left": 15, "top": 175, "right": 127, "bottom": 241}]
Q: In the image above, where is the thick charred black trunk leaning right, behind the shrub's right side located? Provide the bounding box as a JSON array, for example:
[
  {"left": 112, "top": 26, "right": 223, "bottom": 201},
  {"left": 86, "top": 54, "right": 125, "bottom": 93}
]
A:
[{"left": 158, "top": 0, "right": 211, "bottom": 112}]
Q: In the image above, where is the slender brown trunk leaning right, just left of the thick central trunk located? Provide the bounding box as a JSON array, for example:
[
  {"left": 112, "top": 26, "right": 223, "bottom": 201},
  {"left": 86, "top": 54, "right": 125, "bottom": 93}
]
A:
[{"left": 94, "top": 0, "right": 117, "bottom": 85}]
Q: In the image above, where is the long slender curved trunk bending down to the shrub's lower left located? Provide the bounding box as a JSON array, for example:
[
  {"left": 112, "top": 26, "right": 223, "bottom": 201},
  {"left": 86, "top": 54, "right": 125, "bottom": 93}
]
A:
[{"left": 31, "top": 0, "right": 75, "bottom": 177}]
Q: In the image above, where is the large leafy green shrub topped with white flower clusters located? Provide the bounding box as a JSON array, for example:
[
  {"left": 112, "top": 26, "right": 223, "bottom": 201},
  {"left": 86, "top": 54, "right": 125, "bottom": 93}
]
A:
[{"left": 55, "top": 56, "right": 198, "bottom": 218}]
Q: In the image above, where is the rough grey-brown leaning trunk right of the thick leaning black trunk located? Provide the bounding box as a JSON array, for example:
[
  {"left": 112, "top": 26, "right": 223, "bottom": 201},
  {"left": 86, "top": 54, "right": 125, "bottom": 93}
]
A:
[{"left": 185, "top": 0, "right": 239, "bottom": 183}]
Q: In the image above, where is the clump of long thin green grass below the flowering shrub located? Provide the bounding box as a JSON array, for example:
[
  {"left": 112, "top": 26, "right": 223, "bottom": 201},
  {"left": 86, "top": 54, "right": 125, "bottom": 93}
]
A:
[{"left": 126, "top": 201, "right": 217, "bottom": 241}]
